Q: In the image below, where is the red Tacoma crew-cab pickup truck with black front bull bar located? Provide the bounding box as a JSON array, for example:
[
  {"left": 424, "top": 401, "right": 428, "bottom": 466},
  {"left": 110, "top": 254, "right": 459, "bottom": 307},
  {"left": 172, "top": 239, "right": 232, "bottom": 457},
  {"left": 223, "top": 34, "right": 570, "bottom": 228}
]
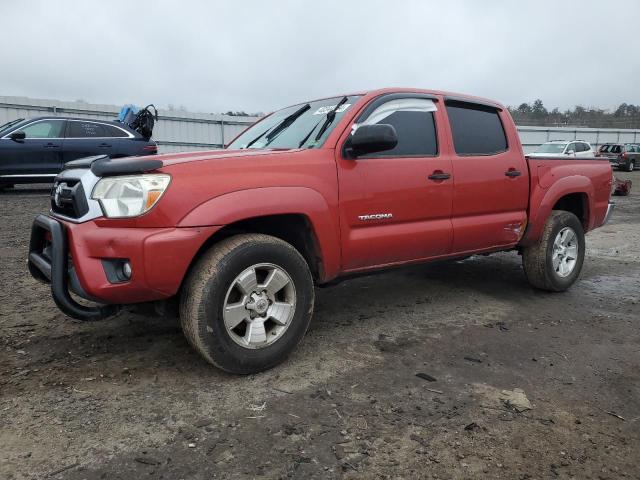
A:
[{"left": 28, "top": 89, "right": 613, "bottom": 373}]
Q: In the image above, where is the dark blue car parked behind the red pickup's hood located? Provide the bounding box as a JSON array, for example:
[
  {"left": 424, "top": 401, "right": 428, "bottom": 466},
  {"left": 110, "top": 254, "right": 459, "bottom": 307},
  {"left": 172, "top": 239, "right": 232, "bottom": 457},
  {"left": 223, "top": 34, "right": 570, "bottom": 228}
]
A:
[{"left": 0, "top": 117, "right": 158, "bottom": 188}]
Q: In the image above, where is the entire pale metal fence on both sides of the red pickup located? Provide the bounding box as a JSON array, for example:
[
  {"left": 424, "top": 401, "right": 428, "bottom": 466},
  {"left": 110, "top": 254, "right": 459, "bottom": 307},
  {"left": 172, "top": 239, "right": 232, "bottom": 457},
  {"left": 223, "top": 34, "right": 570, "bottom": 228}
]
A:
[{"left": 0, "top": 97, "right": 640, "bottom": 153}]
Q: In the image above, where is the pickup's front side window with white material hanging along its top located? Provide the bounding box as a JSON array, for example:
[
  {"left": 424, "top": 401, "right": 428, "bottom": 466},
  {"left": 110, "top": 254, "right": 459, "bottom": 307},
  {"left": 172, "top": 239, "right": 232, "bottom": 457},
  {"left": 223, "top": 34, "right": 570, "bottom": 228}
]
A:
[{"left": 352, "top": 98, "right": 438, "bottom": 158}]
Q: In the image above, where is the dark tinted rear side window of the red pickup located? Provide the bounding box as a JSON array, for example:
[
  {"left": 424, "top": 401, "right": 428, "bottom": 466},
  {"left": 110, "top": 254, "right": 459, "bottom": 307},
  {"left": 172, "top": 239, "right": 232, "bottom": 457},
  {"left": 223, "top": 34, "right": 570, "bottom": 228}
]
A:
[{"left": 446, "top": 102, "right": 507, "bottom": 155}]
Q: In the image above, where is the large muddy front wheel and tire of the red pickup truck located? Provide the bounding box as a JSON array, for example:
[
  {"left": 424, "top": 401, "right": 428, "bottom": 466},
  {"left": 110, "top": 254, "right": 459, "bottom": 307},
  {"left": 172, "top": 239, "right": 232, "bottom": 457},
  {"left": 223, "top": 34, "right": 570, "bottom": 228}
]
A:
[{"left": 180, "top": 234, "right": 314, "bottom": 374}]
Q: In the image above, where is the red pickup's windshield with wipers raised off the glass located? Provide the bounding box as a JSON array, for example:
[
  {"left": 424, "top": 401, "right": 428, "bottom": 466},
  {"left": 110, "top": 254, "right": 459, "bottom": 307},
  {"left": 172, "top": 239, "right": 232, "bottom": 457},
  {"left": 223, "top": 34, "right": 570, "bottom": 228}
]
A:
[{"left": 227, "top": 95, "right": 360, "bottom": 149}]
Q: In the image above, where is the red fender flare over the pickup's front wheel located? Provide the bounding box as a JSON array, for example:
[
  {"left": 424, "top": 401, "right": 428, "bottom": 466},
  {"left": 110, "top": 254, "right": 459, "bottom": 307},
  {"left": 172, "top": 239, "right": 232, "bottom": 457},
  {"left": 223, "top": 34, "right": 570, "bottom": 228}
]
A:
[{"left": 178, "top": 187, "right": 341, "bottom": 281}]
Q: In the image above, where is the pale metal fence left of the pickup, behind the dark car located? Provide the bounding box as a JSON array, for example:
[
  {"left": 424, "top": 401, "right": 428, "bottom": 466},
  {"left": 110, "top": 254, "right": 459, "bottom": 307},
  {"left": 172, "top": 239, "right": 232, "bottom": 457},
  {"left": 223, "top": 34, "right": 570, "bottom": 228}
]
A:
[{"left": 0, "top": 97, "right": 258, "bottom": 153}]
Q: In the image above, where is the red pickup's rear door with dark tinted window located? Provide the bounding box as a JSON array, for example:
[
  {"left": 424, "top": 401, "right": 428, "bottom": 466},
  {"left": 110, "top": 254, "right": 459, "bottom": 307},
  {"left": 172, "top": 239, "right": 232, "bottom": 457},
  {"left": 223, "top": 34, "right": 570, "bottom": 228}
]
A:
[{"left": 446, "top": 99, "right": 529, "bottom": 253}]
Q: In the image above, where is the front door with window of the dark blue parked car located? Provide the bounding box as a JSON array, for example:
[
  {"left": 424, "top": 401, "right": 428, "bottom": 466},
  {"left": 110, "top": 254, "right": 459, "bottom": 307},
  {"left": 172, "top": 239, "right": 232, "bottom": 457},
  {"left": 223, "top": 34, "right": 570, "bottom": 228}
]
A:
[{"left": 0, "top": 119, "right": 65, "bottom": 177}]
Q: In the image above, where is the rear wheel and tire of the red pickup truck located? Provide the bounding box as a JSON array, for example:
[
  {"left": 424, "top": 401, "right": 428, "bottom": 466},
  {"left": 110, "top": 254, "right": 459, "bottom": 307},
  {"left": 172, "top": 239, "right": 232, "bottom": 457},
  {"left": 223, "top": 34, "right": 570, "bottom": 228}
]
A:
[{"left": 522, "top": 210, "right": 585, "bottom": 292}]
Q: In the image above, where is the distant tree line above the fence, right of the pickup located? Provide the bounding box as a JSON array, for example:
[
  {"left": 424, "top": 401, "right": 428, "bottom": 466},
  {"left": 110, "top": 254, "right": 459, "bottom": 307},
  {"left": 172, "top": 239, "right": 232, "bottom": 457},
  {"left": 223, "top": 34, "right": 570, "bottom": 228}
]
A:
[{"left": 507, "top": 99, "right": 640, "bottom": 128}]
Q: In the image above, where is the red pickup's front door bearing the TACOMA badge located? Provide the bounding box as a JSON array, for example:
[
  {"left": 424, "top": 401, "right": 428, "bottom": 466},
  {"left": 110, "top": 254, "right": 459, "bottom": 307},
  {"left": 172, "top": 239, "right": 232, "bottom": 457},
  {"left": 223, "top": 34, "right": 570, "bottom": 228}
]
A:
[{"left": 336, "top": 94, "right": 453, "bottom": 271}]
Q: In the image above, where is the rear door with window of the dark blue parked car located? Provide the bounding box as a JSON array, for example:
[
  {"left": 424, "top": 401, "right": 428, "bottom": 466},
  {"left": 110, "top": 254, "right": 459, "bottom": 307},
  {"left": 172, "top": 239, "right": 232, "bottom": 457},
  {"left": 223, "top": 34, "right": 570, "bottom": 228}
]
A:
[{"left": 63, "top": 120, "right": 118, "bottom": 163}]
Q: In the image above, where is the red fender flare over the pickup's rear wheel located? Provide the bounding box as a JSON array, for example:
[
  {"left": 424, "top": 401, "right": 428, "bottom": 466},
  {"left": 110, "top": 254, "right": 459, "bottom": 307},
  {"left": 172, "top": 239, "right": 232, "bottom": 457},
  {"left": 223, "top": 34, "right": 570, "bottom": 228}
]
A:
[{"left": 520, "top": 175, "right": 595, "bottom": 245}]
